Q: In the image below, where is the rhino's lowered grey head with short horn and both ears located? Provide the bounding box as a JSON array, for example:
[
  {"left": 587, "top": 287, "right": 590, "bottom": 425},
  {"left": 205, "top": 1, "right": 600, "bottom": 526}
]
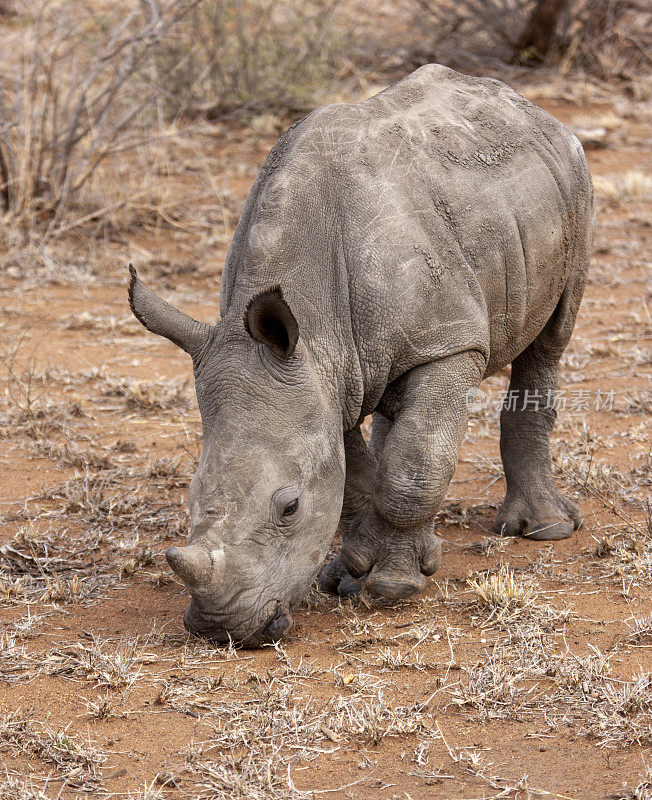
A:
[{"left": 129, "top": 267, "right": 344, "bottom": 647}]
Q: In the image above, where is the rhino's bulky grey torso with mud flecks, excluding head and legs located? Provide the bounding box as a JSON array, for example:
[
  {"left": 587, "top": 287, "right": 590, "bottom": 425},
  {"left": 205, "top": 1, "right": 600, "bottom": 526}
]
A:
[{"left": 223, "top": 65, "right": 593, "bottom": 407}]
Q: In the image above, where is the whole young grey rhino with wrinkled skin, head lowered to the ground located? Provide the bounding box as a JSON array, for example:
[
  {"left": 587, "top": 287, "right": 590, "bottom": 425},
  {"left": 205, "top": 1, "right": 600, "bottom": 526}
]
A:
[{"left": 130, "top": 65, "right": 594, "bottom": 645}]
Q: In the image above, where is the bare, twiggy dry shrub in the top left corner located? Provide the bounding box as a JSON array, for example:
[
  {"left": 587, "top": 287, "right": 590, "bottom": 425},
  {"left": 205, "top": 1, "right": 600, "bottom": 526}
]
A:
[{"left": 0, "top": 0, "right": 192, "bottom": 232}]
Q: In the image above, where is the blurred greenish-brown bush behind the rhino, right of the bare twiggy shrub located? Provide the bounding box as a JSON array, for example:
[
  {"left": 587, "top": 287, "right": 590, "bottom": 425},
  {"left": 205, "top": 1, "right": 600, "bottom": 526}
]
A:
[{"left": 159, "top": 0, "right": 346, "bottom": 120}]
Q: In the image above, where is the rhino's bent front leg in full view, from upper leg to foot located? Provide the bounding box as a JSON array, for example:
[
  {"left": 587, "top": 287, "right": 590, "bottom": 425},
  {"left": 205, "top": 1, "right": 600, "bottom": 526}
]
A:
[{"left": 341, "top": 352, "right": 484, "bottom": 598}]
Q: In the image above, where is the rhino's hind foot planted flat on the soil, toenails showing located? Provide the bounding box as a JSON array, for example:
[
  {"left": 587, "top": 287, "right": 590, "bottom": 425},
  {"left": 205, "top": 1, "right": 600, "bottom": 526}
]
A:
[{"left": 494, "top": 489, "right": 583, "bottom": 541}]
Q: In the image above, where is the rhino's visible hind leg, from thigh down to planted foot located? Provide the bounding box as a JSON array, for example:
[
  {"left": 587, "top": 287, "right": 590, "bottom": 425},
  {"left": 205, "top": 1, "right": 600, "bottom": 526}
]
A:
[{"left": 494, "top": 278, "right": 582, "bottom": 541}]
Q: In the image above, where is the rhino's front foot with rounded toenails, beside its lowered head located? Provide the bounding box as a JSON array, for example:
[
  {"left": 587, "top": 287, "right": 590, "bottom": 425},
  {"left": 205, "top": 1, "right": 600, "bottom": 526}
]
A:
[{"left": 340, "top": 513, "right": 441, "bottom": 600}]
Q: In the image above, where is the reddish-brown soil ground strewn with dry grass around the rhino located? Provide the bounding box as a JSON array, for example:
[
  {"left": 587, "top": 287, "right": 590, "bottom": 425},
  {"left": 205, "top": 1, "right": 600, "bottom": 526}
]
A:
[{"left": 0, "top": 84, "right": 652, "bottom": 800}]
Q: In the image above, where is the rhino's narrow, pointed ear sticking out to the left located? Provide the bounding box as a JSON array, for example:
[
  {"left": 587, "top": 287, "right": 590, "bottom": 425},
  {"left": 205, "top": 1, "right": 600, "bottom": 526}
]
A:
[{"left": 129, "top": 264, "right": 213, "bottom": 360}]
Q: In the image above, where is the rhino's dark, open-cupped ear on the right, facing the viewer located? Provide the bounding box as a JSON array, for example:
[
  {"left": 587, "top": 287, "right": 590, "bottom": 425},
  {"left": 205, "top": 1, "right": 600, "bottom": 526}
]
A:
[{"left": 244, "top": 286, "right": 299, "bottom": 358}]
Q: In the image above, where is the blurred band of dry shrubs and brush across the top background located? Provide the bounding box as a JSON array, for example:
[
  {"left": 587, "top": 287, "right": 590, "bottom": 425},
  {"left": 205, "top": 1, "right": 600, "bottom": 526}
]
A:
[{"left": 0, "top": 0, "right": 651, "bottom": 241}]
